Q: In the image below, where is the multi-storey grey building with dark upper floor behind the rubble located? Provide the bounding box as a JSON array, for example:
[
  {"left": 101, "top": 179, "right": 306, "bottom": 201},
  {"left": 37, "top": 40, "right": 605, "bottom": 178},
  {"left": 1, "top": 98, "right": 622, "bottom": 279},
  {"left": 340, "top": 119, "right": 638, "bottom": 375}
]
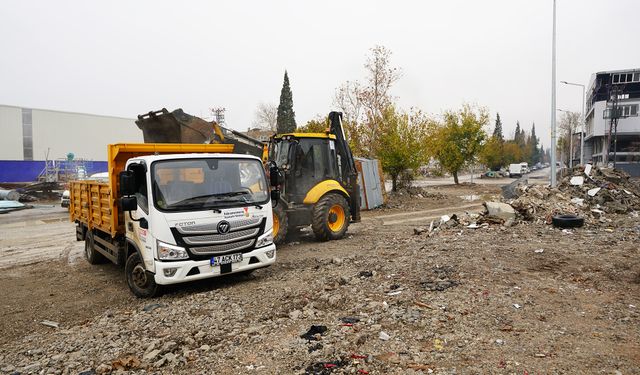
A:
[{"left": 584, "top": 69, "right": 640, "bottom": 176}]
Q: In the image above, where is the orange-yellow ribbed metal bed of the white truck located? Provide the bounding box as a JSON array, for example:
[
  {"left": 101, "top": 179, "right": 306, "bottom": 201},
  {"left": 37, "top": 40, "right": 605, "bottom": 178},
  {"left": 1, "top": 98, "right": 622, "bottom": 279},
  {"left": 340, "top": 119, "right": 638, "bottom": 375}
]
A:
[{"left": 69, "top": 143, "right": 233, "bottom": 237}]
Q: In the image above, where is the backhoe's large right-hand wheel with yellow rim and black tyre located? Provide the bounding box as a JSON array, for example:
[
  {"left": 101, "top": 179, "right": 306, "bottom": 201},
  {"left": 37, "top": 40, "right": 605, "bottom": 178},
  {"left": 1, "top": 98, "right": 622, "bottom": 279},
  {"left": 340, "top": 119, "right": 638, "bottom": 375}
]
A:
[{"left": 311, "top": 194, "right": 351, "bottom": 241}]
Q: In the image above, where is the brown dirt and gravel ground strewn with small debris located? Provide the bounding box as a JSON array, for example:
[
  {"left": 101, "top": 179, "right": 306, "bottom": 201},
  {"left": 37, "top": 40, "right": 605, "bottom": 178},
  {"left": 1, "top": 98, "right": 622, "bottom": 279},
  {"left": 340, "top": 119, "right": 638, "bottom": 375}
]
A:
[{"left": 0, "top": 180, "right": 640, "bottom": 374}]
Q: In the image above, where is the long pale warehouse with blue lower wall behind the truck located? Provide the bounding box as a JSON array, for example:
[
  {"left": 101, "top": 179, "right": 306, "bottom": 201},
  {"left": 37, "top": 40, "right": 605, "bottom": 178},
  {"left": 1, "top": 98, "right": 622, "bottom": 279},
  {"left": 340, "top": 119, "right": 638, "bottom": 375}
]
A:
[{"left": 0, "top": 104, "right": 142, "bottom": 182}]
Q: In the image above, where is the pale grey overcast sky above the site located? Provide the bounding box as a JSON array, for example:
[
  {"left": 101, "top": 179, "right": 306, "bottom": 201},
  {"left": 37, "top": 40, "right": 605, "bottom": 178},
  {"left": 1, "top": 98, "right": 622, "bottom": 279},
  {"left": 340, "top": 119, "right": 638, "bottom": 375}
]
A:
[{"left": 0, "top": 0, "right": 640, "bottom": 146}]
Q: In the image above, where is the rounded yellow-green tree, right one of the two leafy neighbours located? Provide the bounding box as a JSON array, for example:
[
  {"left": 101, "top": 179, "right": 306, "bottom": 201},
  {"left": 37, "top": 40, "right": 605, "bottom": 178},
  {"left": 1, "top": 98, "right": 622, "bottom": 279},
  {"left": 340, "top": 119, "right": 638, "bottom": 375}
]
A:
[{"left": 429, "top": 105, "right": 489, "bottom": 184}]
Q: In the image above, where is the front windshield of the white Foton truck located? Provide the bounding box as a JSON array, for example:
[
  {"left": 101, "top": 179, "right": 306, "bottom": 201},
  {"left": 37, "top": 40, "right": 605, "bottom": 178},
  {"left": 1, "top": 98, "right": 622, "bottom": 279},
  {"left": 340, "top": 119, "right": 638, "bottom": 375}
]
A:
[{"left": 151, "top": 158, "right": 269, "bottom": 211}]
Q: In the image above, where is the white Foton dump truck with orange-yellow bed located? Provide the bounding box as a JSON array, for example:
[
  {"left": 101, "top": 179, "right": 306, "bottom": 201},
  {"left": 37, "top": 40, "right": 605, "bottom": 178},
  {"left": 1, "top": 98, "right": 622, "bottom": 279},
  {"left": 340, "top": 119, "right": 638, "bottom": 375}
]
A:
[{"left": 69, "top": 144, "right": 279, "bottom": 297}]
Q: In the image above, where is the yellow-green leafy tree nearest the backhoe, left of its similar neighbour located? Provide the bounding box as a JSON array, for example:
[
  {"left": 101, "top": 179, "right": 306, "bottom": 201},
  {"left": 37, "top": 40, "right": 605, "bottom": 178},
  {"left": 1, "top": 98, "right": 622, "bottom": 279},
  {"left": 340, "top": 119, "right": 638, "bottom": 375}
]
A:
[{"left": 378, "top": 106, "right": 430, "bottom": 191}]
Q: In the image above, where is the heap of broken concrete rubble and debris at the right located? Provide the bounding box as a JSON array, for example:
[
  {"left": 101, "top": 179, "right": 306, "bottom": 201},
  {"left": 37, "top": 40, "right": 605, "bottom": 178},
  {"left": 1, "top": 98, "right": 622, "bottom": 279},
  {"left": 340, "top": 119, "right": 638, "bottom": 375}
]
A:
[{"left": 505, "top": 165, "right": 640, "bottom": 224}]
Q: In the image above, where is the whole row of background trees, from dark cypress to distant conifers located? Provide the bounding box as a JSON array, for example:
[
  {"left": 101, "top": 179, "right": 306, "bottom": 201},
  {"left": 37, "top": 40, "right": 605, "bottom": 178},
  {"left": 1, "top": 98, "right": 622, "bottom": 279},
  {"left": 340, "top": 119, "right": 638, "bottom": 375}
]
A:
[{"left": 256, "top": 46, "right": 544, "bottom": 191}]
